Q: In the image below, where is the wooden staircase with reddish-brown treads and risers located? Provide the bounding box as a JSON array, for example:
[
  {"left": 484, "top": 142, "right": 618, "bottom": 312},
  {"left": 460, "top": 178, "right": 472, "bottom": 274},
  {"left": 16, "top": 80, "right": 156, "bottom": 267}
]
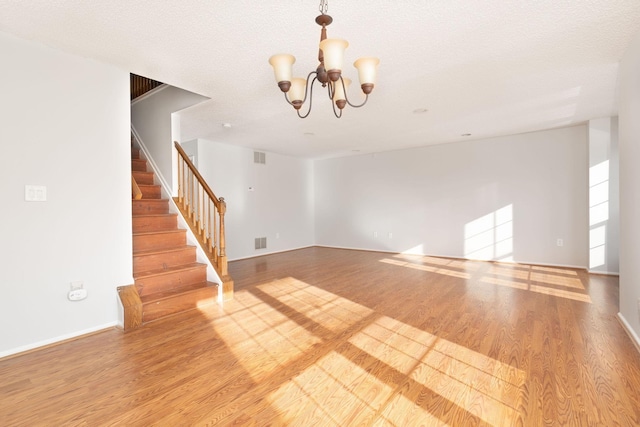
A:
[{"left": 118, "top": 148, "right": 218, "bottom": 330}]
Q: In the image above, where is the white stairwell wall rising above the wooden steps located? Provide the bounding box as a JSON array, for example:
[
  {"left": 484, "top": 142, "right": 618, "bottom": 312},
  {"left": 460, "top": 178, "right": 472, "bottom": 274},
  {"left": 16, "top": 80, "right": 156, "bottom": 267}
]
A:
[{"left": 131, "top": 86, "right": 208, "bottom": 196}]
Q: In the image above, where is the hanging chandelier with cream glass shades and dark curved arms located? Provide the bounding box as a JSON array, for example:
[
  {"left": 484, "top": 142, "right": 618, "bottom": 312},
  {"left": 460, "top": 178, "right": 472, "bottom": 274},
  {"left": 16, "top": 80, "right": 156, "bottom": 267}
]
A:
[{"left": 269, "top": 0, "right": 380, "bottom": 119}]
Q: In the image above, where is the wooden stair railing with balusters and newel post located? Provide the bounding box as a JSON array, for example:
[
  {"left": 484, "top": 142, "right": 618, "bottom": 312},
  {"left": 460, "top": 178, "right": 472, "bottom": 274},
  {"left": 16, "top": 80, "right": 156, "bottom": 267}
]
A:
[{"left": 174, "top": 142, "right": 233, "bottom": 284}]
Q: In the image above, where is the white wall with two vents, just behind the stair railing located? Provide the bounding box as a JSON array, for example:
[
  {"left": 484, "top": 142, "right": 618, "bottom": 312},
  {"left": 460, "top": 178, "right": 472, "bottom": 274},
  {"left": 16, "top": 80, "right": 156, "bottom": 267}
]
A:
[{"left": 197, "top": 139, "right": 314, "bottom": 260}]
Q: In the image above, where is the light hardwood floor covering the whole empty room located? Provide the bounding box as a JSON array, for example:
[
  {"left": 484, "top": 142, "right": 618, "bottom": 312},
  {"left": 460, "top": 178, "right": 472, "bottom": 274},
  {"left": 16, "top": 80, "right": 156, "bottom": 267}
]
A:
[{"left": 0, "top": 247, "right": 640, "bottom": 426}]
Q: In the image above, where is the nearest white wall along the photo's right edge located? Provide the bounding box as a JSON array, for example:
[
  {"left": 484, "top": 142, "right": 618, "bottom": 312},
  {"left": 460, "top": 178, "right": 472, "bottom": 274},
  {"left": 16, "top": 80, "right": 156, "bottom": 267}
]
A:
[{"left": 618, "top": 29, "right": 640, "bottom": 344}]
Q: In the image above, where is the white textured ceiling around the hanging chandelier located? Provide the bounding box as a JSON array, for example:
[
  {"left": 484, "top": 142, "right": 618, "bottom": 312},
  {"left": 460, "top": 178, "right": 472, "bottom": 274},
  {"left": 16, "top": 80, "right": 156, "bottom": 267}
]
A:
[{"left": 0, "top": 0, "right": 640, "bottom": 158}]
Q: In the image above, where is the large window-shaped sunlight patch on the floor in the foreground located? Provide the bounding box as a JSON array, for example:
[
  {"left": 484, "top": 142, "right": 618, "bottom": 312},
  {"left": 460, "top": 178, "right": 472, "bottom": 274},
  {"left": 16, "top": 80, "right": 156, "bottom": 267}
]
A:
[{"left": 213, "top": 278, "right": 526, "bottom": 426}]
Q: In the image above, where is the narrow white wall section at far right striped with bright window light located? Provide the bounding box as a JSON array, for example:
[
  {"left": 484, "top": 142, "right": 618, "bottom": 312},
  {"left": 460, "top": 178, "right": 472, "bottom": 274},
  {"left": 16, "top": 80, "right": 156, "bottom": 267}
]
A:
[{"left": 589, "top": 117, "right": 620, "bottom": 274}]
